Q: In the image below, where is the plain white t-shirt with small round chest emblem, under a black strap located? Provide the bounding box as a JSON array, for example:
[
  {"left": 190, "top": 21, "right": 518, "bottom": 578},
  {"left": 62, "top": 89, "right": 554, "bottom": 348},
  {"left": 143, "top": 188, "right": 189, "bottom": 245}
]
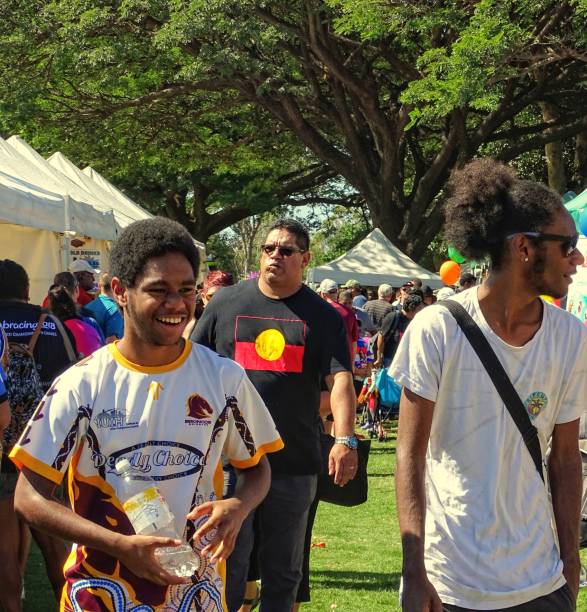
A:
[{"left": 389, "top": 287, "right": 587, "bottom": 610}]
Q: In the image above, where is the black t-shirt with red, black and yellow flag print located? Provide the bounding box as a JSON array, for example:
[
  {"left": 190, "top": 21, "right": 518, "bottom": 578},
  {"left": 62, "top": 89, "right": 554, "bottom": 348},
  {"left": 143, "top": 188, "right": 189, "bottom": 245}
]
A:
[{"left": 192, "top": 280, "right": 351, "bottom": 474}]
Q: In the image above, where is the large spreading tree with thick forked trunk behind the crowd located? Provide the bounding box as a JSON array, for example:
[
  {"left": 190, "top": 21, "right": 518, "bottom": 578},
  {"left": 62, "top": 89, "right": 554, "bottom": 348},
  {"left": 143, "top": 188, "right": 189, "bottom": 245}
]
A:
[{"left": 0, "top": 0, "right": 587, "bottom": 258}]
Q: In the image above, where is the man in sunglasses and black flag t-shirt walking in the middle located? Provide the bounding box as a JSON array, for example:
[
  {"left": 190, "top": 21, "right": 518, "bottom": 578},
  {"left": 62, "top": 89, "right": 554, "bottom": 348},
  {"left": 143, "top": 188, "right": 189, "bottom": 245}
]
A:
[{"left": 192, "top": 219, "right": 357, "bottom": 612}]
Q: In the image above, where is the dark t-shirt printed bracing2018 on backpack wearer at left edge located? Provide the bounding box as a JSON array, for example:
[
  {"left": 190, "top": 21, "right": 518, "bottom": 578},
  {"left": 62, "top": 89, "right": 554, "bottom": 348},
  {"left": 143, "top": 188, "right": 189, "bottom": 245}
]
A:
[{"left": 0, "top": 300, "right": 77, "bottom": 391}]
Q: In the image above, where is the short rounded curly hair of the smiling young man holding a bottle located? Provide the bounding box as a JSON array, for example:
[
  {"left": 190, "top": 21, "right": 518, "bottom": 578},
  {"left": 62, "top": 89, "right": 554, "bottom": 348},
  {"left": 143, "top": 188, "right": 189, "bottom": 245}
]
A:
[{"left": 110, "top": 217, "right": 200, "bottom": 287}]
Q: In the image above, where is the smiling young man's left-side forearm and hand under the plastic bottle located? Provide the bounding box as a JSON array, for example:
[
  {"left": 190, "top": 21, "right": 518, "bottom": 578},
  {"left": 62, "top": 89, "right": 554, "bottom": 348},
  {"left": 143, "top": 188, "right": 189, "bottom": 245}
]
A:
[{"left": 14, "top": 467, "right": 189, "bottom": 586}]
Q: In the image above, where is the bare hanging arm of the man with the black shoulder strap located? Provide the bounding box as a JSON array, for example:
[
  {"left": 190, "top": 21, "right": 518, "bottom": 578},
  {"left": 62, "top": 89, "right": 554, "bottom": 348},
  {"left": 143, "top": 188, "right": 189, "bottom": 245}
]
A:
[{"left": 395, "top": 388, "right": 442, "bottom": 612}]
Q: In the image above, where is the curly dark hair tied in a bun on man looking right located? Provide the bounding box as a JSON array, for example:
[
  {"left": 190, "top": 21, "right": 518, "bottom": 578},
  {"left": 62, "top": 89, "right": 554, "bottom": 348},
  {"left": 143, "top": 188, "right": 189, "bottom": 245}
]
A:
[{"left": 444, "top": 158, "right": 562, "bottom": 269}]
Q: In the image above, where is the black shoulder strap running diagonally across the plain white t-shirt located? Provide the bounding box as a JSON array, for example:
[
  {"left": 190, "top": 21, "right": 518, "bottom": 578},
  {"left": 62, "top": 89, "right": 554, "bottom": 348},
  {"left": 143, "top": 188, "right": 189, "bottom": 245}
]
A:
[{"left": 438, "top": 300, "right": 544, "bottom": 482}]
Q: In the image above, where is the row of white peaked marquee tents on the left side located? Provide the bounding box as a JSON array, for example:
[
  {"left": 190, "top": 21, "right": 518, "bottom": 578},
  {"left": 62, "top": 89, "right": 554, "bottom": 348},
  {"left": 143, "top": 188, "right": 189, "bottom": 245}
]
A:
[{"left": 0, "top": 136, "right": 205, "bottom": 303}]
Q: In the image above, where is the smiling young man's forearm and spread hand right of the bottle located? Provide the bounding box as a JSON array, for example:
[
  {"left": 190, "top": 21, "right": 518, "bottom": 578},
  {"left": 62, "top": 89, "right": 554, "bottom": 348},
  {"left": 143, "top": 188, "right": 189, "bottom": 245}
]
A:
[{"left": 187, "top": 456, "right": 271, "bottom": 563}]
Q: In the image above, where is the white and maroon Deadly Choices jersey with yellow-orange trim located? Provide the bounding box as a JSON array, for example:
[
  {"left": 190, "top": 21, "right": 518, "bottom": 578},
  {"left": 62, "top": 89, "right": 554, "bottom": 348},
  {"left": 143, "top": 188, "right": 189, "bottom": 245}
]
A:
[{"left": 11, "top": 341, "right": 283, "bottom": 611}]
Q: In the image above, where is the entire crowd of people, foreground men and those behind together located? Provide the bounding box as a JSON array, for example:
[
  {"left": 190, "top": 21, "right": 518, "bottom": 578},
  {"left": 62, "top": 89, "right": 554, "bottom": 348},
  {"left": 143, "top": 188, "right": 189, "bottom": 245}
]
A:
[{"left": 0, "top": 155, "right": 587, "bottom": 612}]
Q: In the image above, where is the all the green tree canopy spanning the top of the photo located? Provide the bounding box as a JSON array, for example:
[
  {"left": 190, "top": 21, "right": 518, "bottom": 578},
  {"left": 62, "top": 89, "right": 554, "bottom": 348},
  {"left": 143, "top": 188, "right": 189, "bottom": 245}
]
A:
[{"left": 0, "top": 0, "right": 587, "bottom": 253}]
